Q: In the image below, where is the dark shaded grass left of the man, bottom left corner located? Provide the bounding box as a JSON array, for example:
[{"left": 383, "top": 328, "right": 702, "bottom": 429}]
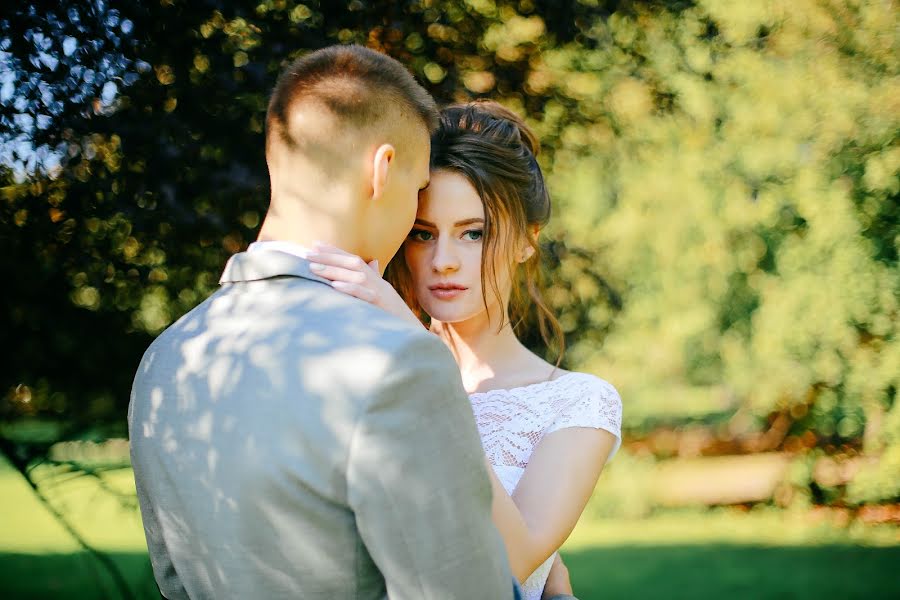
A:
[{"left": 0, "top": 552, "right": 160, "bottom": 600}]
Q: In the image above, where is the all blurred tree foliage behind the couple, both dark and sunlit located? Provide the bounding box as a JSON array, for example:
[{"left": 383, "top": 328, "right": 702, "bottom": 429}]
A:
[{"left": 0, "top": 0, "right": 900, "bottom": 501}]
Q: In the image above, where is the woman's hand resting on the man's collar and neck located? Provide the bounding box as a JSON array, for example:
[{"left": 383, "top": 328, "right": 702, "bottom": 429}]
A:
[{"left": 308, "top": 244, "right": 422, "bottom": 327}]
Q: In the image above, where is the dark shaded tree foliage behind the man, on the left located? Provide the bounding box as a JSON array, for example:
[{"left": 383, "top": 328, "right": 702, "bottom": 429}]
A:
[{"left": 0, "top": 0, "right": 560, "bottom": 438}]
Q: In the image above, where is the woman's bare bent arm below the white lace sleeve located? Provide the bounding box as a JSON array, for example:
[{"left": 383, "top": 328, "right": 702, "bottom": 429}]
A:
[{"left": 489, "top": 427, "right": 616, "bottom": 582}]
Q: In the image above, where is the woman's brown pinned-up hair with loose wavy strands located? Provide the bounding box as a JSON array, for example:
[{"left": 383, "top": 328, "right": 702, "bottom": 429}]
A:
[{"left": 386, "top": 101, "right": 565, "bottom": 366}]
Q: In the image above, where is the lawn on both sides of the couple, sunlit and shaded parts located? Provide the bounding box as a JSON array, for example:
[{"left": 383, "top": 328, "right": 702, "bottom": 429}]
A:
[{"left": 0, "top": 454, "right": 900, "bottom": 600}]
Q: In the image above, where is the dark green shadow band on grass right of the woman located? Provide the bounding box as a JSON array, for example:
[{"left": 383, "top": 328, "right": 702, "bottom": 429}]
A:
[{"left": 562, "top": 544, "right": 900, "bottom": 600}]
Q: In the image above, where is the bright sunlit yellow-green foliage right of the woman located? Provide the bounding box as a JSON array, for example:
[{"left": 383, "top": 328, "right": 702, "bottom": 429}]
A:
[{"left": 529, "top": 1, "right": 900, "bottom": 458}]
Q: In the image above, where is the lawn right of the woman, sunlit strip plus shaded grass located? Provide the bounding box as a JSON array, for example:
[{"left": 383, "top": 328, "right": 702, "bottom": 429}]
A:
[{"left": 562, "top": 509, "right": 900, "bottom": 600}]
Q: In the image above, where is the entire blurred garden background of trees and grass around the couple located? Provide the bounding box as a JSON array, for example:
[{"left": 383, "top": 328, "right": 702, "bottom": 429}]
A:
[{"left": 0, "top": 0, "right": 900, "bottom": 600}]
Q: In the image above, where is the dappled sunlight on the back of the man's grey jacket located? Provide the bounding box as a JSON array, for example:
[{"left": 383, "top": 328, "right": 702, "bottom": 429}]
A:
[{"left": 130, "top": 262, "right": 433, "bottom": 591}]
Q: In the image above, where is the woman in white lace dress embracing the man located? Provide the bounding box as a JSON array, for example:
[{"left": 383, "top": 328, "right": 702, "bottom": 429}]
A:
[{"left": 310, "top": 102, "right": 621, "bottom": 599}]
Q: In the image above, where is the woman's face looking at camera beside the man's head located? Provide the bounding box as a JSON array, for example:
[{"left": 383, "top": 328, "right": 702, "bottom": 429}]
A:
[{"left": 403, "top": 171, "right": 510, "bottom": 323}]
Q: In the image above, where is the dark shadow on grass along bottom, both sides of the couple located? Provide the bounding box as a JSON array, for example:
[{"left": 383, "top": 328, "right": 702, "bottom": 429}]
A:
[{"left": 0, "top": 544, "right": 900, "bottom": 600}]
